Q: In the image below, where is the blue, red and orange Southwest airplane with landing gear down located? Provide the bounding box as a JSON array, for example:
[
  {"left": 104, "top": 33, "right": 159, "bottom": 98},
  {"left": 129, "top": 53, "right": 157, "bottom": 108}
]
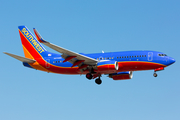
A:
[{"left": 4, "top": 26, "right": 175, "bottom": 85}]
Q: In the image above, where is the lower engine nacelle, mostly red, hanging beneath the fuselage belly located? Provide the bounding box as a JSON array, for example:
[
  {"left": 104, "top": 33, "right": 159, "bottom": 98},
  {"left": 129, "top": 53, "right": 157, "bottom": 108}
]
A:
[{"left": 109, "top": 71, "right": 133, "bottom": 80}]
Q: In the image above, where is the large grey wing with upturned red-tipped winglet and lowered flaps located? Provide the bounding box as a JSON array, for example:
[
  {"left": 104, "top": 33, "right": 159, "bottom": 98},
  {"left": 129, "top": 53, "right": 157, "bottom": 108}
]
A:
[{"left": 34, "top": 28, "right": 98, "bottom": 68}]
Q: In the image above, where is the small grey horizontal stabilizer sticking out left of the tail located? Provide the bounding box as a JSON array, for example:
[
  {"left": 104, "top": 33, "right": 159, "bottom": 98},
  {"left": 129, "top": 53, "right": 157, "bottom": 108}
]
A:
[{"left": 4, "top": 52, "right": 36, "bottom": 63}]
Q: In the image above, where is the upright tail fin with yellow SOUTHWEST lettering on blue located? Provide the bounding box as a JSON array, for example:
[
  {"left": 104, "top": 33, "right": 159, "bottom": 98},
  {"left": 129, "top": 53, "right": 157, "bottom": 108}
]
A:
[{"left": 18, "top": 26, "right": 46, "bottom": 59}]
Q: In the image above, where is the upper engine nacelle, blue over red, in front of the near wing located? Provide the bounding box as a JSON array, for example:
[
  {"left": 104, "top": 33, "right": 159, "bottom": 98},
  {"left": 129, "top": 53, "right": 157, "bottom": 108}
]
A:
[{"left": 97, "top": 61, "right": 119, "bottom": 72}]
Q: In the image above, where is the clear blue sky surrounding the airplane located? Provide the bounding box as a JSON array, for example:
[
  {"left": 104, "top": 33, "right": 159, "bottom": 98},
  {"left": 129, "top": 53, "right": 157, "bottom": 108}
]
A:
[{"left": 0, "top": 0, "right": 180, "bottom": 120}]
